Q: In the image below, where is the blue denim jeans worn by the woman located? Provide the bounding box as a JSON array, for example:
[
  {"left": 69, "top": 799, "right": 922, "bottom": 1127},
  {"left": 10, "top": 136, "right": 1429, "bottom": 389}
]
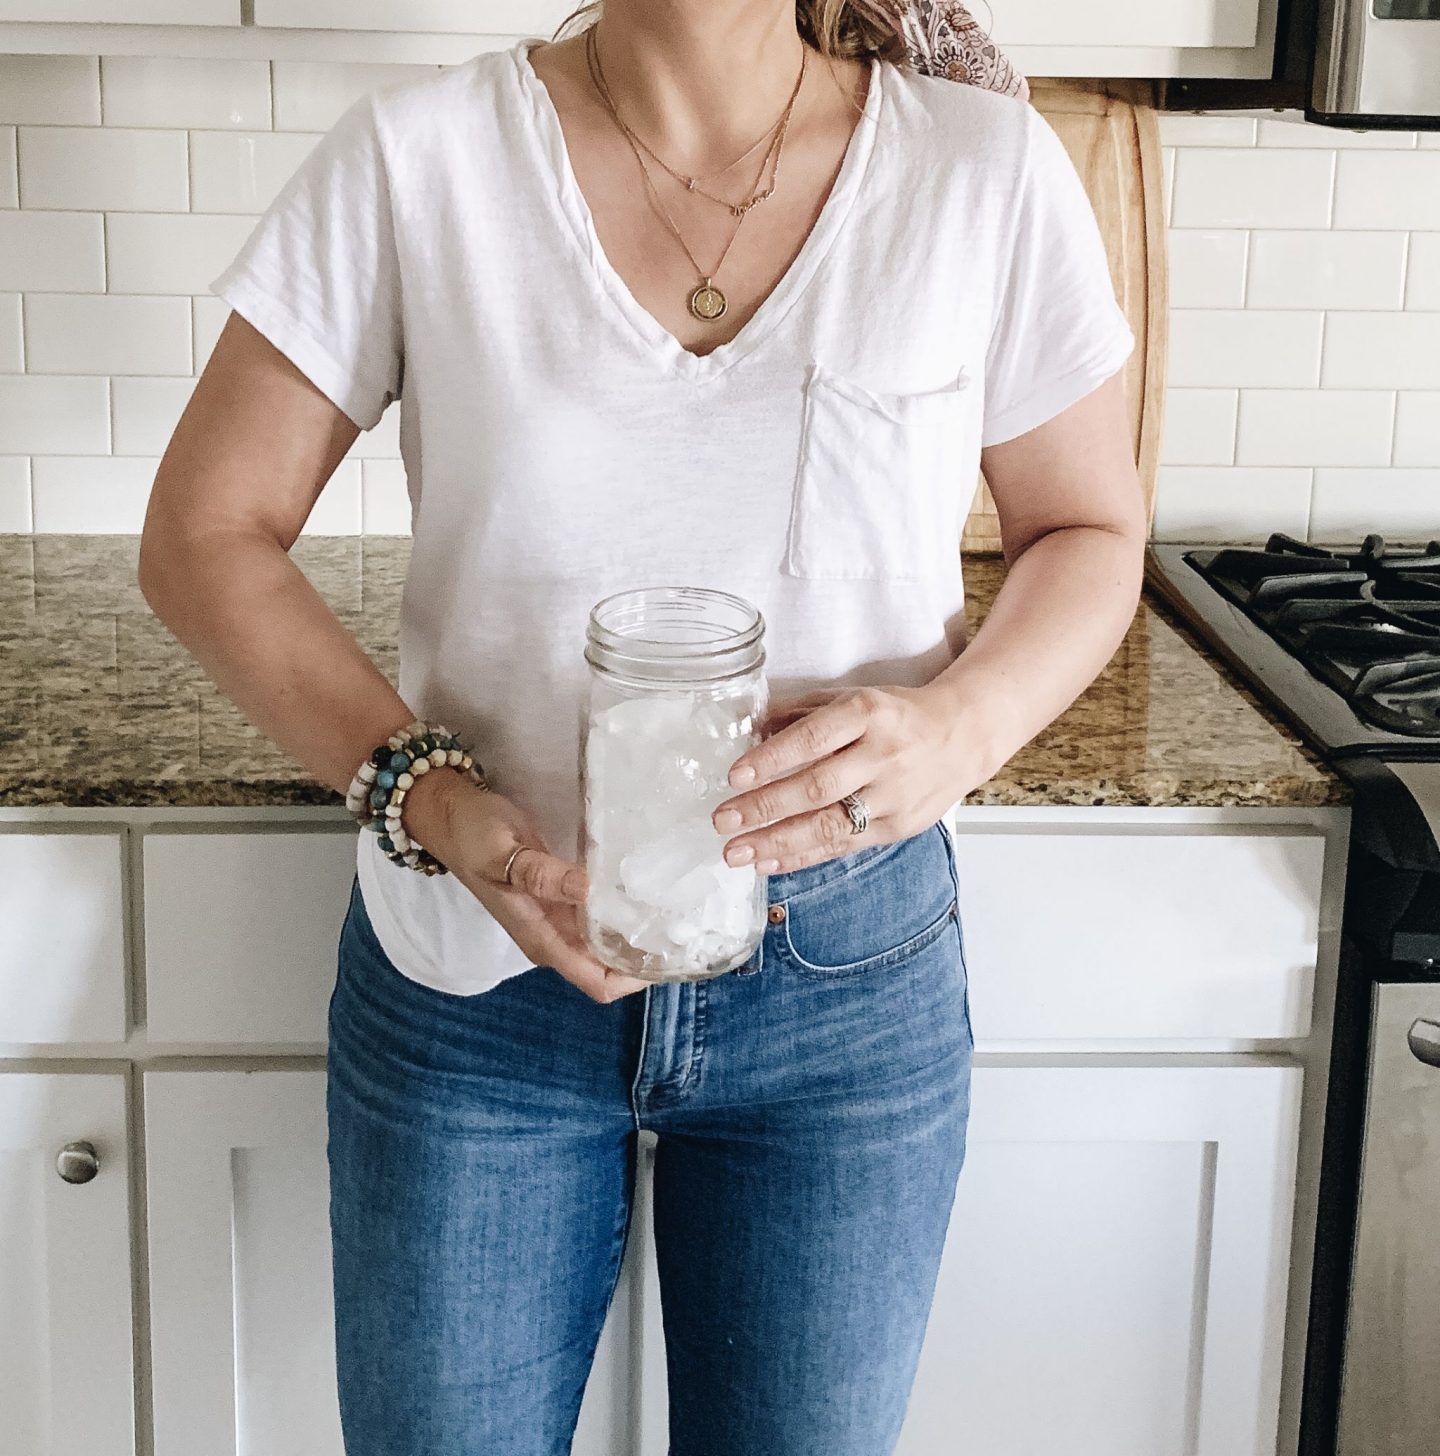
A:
[{"left": 326, "top": 824, "right": 973, "bottom": 1456}]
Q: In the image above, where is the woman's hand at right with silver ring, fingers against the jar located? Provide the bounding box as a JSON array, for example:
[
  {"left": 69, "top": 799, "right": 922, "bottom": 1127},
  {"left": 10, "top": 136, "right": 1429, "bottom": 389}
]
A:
[{"left": 712, "top": 684, "right": 997, "bottom": 875}]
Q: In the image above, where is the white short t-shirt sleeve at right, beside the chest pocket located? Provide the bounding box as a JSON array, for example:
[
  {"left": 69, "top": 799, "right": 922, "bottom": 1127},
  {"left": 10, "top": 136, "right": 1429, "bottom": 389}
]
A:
[{"left": 981, "top": 106, "right": 1136, "bottom": 446}]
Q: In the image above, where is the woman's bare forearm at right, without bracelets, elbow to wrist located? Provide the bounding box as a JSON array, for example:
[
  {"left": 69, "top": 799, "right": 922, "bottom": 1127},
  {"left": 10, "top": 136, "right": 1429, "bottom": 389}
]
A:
[{"left": 929, "top": 526, "right": 1144, "bottom": 792}]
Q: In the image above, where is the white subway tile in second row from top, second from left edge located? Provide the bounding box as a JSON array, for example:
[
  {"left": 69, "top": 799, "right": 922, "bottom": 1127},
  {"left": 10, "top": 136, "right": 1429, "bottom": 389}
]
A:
[{"left": 19, "top": 127, "right": 189, "bottom": 213}]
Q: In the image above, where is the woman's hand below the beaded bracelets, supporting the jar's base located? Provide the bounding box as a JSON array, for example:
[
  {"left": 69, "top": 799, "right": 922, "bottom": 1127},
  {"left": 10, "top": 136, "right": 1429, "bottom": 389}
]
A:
[{"left": 405, "top": 770, "right": 648, "bottom": 1002}]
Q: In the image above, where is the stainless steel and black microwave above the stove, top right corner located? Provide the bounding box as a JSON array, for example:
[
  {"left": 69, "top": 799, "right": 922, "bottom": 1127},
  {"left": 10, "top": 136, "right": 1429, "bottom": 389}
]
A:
[{"left": 1160, "top": 0, "right": 1440, "bottom": 131}]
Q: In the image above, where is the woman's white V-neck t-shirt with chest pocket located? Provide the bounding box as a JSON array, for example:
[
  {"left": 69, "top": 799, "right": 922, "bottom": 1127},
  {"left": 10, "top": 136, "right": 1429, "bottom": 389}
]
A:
[{"left": 214, "top": 39, "right": 1134, "bottom": 994}]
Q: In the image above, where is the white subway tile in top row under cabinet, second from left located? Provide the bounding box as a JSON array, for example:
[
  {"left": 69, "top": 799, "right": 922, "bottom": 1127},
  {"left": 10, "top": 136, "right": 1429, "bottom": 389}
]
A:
[{"left": 100, "top": 55, "right": 269, "bottom": 131}]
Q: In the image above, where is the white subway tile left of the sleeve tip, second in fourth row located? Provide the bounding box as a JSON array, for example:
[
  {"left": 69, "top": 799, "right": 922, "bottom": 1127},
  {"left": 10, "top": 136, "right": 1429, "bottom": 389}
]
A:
[{"left": 25, "top": 293, "right": 191, "bottom": 374}]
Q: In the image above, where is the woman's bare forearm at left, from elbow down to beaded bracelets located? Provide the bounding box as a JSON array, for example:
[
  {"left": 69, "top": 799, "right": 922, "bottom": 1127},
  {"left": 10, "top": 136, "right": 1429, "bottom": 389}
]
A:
[{"left": 140, "top": 531, "right": 414, "bottom": 794}]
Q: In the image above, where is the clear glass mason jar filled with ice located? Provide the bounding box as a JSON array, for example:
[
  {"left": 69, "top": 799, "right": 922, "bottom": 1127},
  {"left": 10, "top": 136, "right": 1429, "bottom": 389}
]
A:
[{"left": 581, "top": 587, "right": 767, "bottom": 981}]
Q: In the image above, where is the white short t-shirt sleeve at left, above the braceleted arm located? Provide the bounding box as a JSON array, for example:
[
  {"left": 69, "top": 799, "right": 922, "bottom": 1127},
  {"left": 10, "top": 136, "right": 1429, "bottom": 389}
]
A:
[{"left": 211, "top": 98, "right": 402, "bottom": 430}]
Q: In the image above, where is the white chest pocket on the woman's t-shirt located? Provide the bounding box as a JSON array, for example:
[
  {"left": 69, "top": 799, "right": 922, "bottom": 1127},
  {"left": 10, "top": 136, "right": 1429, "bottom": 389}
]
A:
[{"left": 782, "top": 364, "right": 974, "bottom": 581}]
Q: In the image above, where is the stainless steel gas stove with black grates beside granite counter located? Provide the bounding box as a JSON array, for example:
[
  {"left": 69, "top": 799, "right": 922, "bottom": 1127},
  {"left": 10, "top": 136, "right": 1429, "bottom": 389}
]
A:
[{"left": 1147, "top": 536, "right": 1440, "bottom": 1456}]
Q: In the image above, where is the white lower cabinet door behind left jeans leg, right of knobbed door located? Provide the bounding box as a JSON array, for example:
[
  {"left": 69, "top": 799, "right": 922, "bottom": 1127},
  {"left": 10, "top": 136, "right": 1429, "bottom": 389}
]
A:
[{"left": 143, "top": 1070, "right": 629, "bottom": 1456}]
